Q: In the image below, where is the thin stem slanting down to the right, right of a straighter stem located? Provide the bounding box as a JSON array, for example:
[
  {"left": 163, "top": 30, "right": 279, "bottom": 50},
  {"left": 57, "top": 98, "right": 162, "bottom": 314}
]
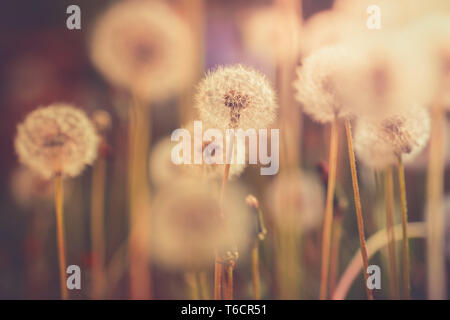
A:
[{"left": 345, "top": 119, "right": 373, "bottom": 300}]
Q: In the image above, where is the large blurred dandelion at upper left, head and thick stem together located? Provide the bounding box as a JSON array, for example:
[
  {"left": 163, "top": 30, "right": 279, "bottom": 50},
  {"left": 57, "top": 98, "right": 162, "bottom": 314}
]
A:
[{"left": 91, "top": 0, "right": 195, "bottom": 299}]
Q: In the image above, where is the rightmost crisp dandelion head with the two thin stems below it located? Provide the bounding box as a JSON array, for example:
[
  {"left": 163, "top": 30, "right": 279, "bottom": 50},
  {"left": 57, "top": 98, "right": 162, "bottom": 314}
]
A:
[{"left": 355, "top": 107, "right": 430, "bottom": 298}]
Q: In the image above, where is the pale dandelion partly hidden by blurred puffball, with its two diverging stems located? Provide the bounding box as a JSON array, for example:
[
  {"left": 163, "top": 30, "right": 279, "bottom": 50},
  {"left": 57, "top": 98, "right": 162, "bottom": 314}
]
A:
[{"left": 294, "top": 46, "right": 373, "bottom": 299}]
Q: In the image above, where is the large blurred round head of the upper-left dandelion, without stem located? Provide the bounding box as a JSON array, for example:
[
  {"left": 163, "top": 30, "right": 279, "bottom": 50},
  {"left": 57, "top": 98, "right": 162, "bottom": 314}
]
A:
[{"left": 91, "top": 0, "right": 195, "bottom": 101}]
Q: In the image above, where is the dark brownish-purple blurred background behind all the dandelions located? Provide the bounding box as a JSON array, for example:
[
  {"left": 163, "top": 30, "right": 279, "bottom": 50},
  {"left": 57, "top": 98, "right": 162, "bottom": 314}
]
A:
[{"left": 0, "top": 0, "right": 450, "bottom": 299}]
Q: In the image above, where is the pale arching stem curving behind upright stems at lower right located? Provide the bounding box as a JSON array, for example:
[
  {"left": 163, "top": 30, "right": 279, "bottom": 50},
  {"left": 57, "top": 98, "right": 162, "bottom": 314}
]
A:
[{"left": 332, "top": 222, "right": 426, "bottom": 300}]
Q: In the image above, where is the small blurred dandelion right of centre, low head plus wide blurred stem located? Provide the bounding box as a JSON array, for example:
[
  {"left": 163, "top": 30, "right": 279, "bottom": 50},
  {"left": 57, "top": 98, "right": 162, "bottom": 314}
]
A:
[{"left": 266, "top": 170, "right": 324, "bottom": 299}]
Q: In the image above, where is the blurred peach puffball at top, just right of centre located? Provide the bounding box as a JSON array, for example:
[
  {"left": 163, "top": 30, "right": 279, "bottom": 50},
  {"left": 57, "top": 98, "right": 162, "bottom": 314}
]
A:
[{"left": 242, "top": 7, "right": 302, "bottom": 62}]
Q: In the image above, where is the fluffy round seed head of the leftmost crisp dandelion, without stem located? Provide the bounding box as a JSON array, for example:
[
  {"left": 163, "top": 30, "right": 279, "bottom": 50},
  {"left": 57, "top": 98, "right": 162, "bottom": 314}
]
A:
[{"left": 15, "top": 103, "right": 99, "bottom": 179}]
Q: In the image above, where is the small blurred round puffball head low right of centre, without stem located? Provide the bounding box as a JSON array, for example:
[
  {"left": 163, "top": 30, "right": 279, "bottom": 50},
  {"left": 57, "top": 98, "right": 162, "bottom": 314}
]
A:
[{"left": 267, "top": 171, "right": 325, "bottom": 232}]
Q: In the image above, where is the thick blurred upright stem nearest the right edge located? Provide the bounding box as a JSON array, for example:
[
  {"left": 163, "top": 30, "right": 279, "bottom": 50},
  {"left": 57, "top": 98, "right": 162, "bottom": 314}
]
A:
[{"left": 427, "top": 103, "right": 447, "bottom": 300}]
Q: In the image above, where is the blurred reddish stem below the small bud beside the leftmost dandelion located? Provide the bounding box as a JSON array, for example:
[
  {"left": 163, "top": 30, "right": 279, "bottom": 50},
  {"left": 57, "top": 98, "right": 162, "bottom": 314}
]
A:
[{"left": 91, "top": 156, "right": 106, "bottom": 299}]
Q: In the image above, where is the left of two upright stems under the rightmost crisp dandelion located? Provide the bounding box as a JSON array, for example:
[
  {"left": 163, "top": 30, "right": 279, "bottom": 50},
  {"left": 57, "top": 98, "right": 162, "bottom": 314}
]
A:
[{"left": 384, "top": 167, "right": 398, "bottom": 299}]
